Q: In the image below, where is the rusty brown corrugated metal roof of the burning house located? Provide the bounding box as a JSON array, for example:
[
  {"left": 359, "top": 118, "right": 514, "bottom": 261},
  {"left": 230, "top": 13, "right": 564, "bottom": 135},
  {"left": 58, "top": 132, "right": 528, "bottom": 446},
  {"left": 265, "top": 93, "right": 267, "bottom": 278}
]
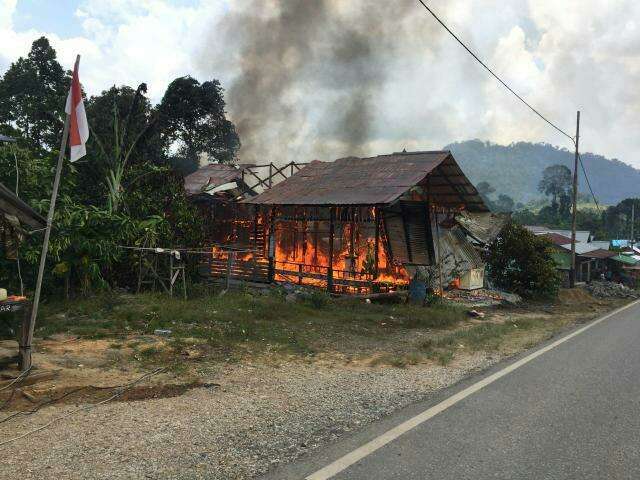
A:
[{"left": 245, "top": 151, "right": 488, "bottom": 211}]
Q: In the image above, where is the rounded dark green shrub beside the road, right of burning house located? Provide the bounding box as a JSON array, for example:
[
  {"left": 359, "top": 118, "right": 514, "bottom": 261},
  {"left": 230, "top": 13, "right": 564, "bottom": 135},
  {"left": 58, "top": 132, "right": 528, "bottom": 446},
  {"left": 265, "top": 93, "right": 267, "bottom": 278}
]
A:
[{"left": 487, "top": 223, "right": 561, "bottom": 298}]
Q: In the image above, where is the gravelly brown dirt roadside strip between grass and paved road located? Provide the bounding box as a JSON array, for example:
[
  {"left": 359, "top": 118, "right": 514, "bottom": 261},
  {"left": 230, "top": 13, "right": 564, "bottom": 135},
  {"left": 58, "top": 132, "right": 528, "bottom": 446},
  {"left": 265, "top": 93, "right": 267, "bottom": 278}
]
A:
[{"left": 0, "top": 290, "right": 625, "bottom": 479}]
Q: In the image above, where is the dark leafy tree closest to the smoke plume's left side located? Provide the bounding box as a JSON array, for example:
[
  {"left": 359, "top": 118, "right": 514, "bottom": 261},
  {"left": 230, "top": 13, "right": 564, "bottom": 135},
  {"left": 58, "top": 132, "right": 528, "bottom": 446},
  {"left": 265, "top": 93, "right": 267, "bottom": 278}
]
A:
[{"left": 159, "top": 77, "right": 240, "bottom": 170}]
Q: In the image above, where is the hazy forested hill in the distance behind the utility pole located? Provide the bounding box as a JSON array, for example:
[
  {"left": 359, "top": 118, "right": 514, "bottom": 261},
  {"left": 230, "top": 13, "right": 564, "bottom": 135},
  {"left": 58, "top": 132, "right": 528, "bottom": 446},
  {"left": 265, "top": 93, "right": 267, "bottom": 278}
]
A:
[{"left": 445, "top": 140, "right": 640, "bottom": 205}]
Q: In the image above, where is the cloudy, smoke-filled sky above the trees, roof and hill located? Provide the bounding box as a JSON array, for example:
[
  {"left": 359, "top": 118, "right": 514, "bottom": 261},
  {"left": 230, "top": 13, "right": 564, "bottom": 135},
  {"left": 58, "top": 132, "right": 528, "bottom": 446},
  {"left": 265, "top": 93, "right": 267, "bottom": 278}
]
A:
[{"left": 0, "top": 0, "right": 640, "bottom": 167}]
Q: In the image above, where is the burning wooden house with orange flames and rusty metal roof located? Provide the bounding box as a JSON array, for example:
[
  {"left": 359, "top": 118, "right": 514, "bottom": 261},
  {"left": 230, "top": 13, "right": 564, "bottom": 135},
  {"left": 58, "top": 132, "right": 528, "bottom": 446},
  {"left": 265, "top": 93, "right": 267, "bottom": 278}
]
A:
[{"left": 200, "top": 151, "right": 504, "bottom": 293}]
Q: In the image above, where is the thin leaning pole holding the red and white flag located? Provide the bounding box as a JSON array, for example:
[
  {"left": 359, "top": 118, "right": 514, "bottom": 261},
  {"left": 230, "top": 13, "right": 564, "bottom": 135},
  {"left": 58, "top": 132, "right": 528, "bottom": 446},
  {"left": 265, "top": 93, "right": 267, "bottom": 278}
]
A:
[{"left": 19, "top": 55, "right": 80, "bottom": 371}]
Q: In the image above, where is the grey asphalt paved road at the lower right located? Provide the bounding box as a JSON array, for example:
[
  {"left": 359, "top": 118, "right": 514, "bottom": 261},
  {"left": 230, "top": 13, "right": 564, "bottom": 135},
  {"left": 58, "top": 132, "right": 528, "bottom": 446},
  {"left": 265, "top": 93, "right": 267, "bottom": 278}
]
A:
[{"left": 269, "top": 304, "right": 640, "bottom": 480}]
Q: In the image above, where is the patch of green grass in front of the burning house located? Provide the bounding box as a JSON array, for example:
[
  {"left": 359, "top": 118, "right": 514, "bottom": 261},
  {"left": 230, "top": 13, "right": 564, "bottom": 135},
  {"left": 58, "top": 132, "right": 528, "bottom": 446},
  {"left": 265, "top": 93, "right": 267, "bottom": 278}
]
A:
[{"left": 37, "top": 290, "right": 466, "bottom": 367}]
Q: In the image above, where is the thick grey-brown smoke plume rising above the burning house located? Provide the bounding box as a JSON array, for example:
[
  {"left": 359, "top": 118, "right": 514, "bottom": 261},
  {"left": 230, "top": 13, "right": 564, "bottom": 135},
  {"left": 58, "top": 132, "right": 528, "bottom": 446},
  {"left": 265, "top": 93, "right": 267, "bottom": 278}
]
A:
[{"left": 209, "top": 0, "right": 433, "bottom": 163}]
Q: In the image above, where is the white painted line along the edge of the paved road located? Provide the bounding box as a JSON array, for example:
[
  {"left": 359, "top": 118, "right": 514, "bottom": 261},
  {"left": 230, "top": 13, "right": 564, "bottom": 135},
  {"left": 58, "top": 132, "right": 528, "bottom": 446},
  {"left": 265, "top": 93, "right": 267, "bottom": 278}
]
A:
[{"left": 306, "top": 300, "right": 640, "bottom": 480}]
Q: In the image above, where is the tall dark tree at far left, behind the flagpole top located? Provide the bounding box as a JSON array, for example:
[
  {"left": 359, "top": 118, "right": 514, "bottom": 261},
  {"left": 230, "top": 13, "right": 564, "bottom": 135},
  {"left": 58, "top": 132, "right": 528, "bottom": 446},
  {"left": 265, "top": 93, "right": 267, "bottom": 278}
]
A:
[{"left": 0, "top": 37, "right": 70, "bottom": 150}]
